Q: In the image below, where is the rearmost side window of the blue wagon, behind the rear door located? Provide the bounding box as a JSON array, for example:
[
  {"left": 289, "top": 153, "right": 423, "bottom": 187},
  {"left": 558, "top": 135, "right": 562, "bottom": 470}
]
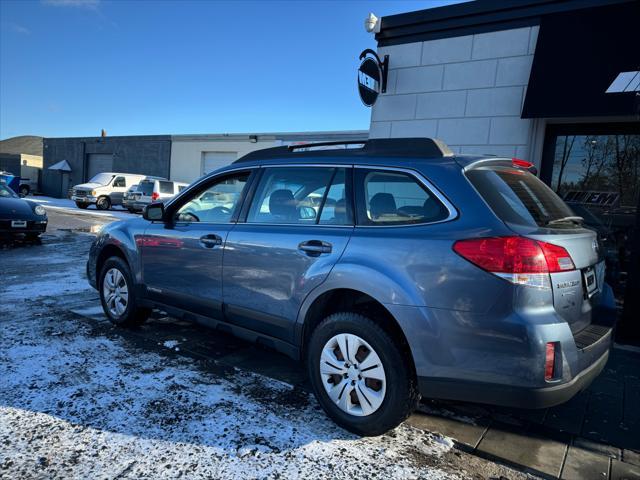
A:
[{"left": 356, "top": 169, "right": 449, "bottom": 225}]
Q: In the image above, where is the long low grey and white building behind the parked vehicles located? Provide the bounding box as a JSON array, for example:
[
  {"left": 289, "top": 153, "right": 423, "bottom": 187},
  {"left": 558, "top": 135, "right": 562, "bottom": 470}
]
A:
[{"left": 42, "top": 130, "right": 369, "bottom": 197}]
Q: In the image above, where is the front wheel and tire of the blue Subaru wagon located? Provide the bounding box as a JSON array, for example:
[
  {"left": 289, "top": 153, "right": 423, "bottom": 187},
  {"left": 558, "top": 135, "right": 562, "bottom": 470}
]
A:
[{"left": 98, "top": 257, "right": 151, "bottom": 327}]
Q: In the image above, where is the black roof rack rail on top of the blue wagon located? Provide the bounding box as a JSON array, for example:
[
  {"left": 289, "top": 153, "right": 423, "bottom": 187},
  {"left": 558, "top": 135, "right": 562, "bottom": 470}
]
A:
[{"left": 233, "top": 138, "right": 453, "bottom": 163}]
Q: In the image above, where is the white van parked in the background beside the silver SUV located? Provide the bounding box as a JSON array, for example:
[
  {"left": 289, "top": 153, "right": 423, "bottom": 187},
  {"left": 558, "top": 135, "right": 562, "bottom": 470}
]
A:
[{"left": 71, "top": 172, "right": 164, "bottom": 210}]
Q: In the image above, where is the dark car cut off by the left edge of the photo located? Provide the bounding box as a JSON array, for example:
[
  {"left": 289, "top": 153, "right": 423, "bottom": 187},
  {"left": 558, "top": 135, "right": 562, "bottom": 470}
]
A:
[{"left": 0, "top": 183, "right": 48, "bottom": 240}]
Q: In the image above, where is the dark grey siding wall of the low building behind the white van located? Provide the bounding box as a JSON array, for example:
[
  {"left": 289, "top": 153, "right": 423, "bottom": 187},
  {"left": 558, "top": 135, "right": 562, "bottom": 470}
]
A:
[{"left": 42, "top": 135, "right": 171, "bottom": 197}]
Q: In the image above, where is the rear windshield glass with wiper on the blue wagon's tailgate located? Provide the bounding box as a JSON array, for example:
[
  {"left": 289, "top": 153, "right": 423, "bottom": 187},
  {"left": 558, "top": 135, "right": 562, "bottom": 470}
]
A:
[{"left": 467, "top": 167, "right": 578, "bottom": 228}]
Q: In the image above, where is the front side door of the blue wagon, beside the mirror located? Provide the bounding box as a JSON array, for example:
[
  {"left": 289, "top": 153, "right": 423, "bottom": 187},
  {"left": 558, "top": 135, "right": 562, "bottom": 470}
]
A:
[{"left": 138, "top": 170, "right": 251, "bottom": 318}]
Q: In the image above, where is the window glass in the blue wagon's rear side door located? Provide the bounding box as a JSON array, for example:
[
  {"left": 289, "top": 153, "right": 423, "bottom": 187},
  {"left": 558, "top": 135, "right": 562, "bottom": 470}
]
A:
[{"left": 247, "top": 167, "right": 344, "bottom": 225}]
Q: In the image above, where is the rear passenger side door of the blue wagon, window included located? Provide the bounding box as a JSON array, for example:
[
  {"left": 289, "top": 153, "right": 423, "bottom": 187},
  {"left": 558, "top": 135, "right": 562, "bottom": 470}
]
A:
[{"left": 223, "top": 166, "right": 353, "bottom": 342}]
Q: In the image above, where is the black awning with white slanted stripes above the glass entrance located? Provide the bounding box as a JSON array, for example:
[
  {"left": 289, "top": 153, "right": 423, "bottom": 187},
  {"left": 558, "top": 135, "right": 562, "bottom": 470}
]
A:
[{"left": 522, "top": 1, "right": 640, "bottom": 118}]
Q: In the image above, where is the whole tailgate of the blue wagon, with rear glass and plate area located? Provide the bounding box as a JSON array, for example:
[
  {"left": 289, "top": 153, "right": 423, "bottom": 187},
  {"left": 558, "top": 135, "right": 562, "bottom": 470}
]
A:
[{"left": 467, "top": 165, "right": 606, "bottom": 333}]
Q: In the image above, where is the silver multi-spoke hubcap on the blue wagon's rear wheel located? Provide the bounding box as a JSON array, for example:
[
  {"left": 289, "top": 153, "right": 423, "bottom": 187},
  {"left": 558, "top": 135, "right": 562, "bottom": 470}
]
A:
[{"left": 320, "top": 333, "right": 387, "bottom": 417}]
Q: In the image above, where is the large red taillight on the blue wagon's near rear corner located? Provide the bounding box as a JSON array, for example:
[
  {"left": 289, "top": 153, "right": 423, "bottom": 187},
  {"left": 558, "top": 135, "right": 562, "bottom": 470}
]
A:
[{"left": 453, "top": 236, "right": 575, "bottom": 288}]
